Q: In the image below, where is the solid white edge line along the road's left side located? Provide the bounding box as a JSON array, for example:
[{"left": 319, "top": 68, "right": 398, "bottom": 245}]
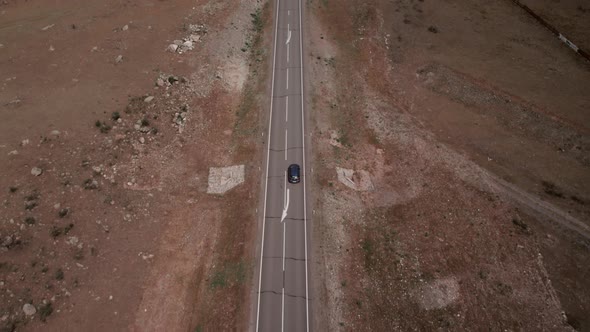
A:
[{"left": 256, "top": 0, "right": 281, "bottom": 331}]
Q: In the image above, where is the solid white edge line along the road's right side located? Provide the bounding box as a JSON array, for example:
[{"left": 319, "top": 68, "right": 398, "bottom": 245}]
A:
[{"left": 298, "top": 0, "right": 309, "bottom": 331}]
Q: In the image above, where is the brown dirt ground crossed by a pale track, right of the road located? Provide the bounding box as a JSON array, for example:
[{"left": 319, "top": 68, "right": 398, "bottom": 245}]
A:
[{"left": 306, "top": 0, "right": 590, "bottom": 331}]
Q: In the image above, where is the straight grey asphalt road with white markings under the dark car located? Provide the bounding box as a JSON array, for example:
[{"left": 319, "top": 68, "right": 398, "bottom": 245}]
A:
[{"left": 256, "top": 0, "right": 310, "bottom": 331}]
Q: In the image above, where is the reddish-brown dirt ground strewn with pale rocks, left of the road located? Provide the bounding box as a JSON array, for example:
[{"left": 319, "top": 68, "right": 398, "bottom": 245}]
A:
[{"left": 0, "top": 0, "right": 271, "bottom": 331}]
